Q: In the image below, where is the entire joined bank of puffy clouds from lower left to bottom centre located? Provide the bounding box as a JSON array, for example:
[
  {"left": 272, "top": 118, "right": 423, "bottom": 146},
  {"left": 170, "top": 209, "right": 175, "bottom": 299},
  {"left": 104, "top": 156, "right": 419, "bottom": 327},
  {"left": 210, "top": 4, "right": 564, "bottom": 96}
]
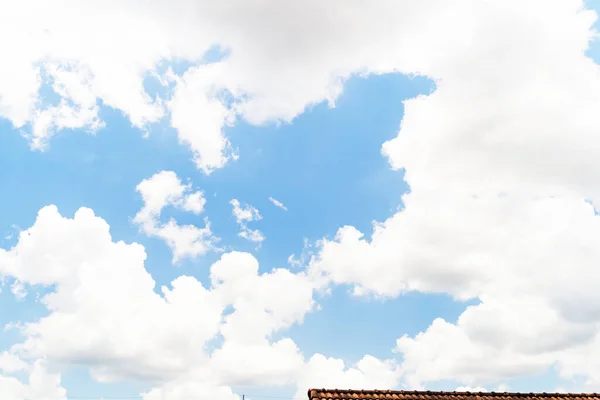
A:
[{"left": 0, "top": 206, "right": 344, "bottom": 399}]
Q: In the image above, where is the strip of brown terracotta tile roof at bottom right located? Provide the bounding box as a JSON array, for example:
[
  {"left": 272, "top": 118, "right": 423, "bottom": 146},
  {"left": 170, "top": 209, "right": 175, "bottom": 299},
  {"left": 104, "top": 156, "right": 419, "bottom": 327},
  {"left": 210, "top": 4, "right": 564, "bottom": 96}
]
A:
[{"left": 308, "top": 389, "right": 600, "bottom": 400}]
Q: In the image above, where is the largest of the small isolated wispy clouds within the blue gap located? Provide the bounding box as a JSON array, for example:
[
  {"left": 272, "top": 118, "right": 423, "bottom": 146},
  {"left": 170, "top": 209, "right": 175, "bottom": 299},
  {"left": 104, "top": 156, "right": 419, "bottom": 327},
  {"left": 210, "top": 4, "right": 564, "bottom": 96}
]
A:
[{"left": 134, "top": 171, "right": 216, "bottom": 262}]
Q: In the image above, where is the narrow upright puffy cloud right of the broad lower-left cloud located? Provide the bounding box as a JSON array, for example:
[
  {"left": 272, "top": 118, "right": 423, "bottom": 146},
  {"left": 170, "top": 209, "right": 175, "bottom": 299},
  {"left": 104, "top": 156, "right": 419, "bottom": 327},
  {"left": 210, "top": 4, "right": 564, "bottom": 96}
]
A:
[{"left": 206, "top": 253, "right": 315, "bottom": 384}]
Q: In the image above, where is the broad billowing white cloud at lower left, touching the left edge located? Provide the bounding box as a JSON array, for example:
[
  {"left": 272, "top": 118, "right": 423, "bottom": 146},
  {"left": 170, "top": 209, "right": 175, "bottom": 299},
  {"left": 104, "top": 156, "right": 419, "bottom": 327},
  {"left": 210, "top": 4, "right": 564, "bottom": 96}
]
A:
[{"left": 0, "top": 207, "right": 223, "bottom": 380}]
